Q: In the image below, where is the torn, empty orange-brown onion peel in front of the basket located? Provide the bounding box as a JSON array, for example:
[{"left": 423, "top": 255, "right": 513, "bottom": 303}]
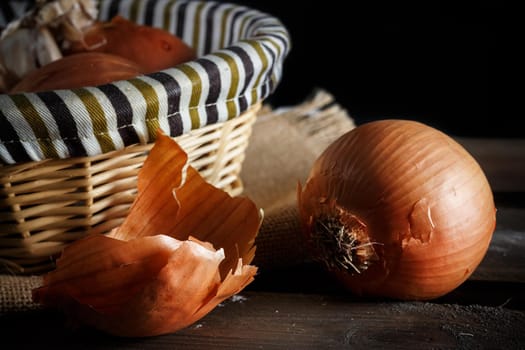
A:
[{"left": 33, "top": 132, "right": 262, "bottom": 337}]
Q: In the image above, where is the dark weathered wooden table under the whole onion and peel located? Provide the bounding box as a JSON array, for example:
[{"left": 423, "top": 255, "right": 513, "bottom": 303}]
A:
[{"left": 0, "top": 139, "right": 525, "bottom": 349}]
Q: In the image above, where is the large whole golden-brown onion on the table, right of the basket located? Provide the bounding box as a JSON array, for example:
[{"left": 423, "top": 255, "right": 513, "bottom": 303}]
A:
[{"left": 298, "top": 119, "right": 496, "bottom": 300}]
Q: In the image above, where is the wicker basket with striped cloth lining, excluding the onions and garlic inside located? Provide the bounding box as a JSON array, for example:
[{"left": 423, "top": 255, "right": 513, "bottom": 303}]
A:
[{"left": 0, "top": 0, "right": 289, "bottom": 274}]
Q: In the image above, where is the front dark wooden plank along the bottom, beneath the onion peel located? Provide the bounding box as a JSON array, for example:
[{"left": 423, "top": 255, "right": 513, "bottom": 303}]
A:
[{"left": 0, "top": 292, "right": 525, "bottom": 350}]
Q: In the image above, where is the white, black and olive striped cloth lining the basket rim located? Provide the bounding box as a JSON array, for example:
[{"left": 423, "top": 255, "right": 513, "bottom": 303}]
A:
[{"left": 0, "top": 0, "right": 290, "bottom": 164}]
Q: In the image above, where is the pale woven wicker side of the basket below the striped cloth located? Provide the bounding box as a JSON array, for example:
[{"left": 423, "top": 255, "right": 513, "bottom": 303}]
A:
[{"left": 0, "top": 104, "right": 260, "bottom": 274}]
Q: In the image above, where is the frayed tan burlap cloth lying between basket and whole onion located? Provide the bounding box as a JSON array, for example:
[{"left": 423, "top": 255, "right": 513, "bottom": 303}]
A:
[{"left": 0, "top": 90, "right": 355, "bottom": 314}]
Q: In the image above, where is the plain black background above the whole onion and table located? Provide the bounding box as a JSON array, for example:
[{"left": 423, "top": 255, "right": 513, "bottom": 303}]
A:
[{"left": 226, "top": 0, "right": 525, "bottom": 137}]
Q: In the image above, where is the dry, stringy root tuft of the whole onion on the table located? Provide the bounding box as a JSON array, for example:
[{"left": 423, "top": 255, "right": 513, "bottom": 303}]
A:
[{"left": 311, "top": 210, "right": 379, "bottom": 275}]
